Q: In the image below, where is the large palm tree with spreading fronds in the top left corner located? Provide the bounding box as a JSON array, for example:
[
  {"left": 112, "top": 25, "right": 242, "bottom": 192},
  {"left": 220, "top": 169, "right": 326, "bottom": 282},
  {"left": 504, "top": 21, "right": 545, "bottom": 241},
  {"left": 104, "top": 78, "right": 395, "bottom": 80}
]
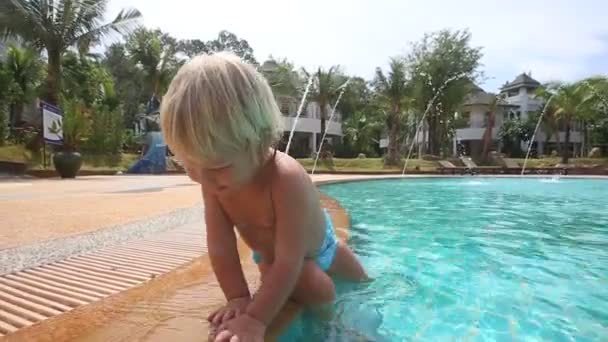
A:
[{"left": 0, "top": 0, "right": 141, "bottom": 104}]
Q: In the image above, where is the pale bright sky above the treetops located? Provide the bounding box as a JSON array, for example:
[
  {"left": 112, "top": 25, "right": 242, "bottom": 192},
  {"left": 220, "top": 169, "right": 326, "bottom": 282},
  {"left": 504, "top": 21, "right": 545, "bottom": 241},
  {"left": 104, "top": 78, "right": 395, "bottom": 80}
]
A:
[{"left": 108, "top": 0, "right": 608, "bottom": 91}]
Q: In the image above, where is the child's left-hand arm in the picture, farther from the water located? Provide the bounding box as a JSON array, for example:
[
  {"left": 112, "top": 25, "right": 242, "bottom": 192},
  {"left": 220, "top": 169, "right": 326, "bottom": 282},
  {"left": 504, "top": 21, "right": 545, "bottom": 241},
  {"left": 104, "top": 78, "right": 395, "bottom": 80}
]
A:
[{"left": 203, "top": 186, "right": 250, "bottom": 301}]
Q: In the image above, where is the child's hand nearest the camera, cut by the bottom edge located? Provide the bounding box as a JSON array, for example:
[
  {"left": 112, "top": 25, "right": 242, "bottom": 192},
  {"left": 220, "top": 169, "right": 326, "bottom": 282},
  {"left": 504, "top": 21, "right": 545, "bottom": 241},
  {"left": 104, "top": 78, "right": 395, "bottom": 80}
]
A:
[{"left": 215, "top": 314, "right": 266, "bottom": 342}]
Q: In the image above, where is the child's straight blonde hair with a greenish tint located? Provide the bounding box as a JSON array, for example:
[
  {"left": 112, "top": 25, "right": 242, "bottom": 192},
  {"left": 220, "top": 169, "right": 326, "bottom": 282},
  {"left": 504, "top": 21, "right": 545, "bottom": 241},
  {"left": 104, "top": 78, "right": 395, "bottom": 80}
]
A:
[{"left": 161, "top": 53, "right": 283, "bottom": 165}]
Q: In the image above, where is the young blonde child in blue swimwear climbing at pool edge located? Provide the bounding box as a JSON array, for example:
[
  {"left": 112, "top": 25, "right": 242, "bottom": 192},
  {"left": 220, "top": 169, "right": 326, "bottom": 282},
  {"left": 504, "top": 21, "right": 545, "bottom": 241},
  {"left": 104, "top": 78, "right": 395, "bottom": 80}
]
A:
[{"left": 161, "top": 53, "right": 367, "bottom": 342}]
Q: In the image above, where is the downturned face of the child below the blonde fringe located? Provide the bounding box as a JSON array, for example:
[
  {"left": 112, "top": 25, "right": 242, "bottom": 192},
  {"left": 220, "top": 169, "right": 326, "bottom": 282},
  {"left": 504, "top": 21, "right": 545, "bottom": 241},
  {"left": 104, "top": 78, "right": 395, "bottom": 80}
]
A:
[{"left": 184, "top": 156, "right": 254, "bottom": 194}]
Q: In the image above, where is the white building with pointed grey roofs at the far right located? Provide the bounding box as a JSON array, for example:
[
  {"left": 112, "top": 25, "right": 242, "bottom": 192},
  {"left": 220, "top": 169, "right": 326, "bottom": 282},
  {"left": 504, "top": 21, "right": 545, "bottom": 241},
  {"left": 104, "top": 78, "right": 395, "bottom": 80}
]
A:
[{"left": 454, "top": 73, "right": 582, "bottom": 156}]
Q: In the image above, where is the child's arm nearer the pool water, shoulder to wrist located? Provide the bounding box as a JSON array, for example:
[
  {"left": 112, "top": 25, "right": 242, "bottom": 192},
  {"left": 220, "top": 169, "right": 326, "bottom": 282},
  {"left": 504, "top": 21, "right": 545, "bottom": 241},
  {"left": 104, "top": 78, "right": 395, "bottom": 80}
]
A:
[{"left": 247, "top": 170, "right": 315, "bottom": 326}]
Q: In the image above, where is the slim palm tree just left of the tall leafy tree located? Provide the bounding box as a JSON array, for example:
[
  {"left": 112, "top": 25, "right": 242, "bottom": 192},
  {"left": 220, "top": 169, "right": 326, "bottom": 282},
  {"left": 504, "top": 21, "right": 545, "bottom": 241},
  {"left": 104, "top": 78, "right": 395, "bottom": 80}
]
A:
[{"left": 374, "top": 58, "right": 410, "bottom": 166}]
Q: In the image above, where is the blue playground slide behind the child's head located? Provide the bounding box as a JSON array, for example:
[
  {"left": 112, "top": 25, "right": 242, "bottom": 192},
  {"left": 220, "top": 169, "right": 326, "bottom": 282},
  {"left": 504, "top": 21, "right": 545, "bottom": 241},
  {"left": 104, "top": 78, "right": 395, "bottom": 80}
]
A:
[{"left": 127, "top": 132, "right": 167, "bottom": 174}]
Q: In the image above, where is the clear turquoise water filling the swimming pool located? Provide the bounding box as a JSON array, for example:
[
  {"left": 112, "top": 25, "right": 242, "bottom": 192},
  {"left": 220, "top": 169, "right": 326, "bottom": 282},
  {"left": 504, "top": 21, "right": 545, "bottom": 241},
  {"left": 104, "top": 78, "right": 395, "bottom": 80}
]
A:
[{"left": 282, "top": 177, "right": 608, "bottom": 341}]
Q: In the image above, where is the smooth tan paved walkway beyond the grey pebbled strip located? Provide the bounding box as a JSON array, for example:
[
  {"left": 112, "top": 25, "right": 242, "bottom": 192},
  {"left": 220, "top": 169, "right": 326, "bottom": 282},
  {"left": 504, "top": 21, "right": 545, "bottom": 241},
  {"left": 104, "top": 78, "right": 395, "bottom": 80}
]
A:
[{"left": 0, "top": 175, "right": 392, "bottom": 250}]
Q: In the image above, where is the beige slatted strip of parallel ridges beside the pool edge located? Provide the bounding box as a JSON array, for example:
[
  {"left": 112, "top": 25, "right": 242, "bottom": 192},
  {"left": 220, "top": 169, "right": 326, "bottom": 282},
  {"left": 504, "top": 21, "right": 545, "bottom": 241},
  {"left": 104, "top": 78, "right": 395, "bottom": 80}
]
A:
[{"left": 0, "top": 225, "right": 207, "bottom": 337}]
